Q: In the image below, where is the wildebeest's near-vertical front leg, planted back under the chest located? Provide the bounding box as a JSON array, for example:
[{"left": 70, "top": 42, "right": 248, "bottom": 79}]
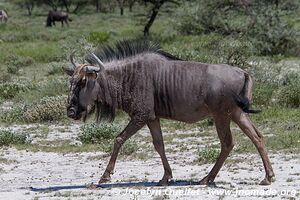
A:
[{"left": 147, "top": 118, "right": 172, "bottom": 185}]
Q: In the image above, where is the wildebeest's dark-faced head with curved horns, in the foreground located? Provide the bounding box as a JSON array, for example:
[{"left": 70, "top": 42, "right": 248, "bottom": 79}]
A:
[{"left": 65, "top": 53, "right": 104, "bottom": 120}]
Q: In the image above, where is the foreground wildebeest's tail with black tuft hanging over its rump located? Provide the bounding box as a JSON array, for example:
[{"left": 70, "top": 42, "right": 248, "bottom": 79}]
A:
[{"left": 234, "top": 73, "right": 261, "bottom": 113}]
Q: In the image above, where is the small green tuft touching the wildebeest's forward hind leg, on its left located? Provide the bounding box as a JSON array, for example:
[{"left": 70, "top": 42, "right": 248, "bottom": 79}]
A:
[{"left": 197, "top": 146, "right": 220, "bottom": 163}]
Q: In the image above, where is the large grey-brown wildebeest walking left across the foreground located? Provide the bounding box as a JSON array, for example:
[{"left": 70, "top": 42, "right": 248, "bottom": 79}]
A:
[{"left": 65, "top": 41, "right": 274, "bottom": 185}]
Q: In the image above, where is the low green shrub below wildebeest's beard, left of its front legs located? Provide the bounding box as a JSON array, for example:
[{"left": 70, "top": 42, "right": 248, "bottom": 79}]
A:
[{"left": 78, "top": 123, "right": 121, "bottom": 146}]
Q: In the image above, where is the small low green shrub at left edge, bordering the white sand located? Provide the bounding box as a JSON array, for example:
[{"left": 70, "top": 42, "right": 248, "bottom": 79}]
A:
[{"left": 0, "top": 130, "right": 27, "bottom": 147}]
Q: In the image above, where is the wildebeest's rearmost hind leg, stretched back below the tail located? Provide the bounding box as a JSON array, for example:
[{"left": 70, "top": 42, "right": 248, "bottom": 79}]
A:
[{"left": 233, "top": 112, "right": 275, "bottom": 185}]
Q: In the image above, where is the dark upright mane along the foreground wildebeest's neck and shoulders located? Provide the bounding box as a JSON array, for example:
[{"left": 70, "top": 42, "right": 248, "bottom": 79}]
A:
[{"left": 86, "top": 39, "right": 181, "bottom": 64}]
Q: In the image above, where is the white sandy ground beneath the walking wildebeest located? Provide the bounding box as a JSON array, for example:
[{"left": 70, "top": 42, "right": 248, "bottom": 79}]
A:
[{"left": 0, "top": 125, "right": 300, "bottom": 200}]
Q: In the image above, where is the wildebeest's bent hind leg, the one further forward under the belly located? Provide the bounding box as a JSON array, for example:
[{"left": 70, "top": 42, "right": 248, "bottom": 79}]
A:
[{"left": 200, "top": 115, "right": 234, "bottom": 185}]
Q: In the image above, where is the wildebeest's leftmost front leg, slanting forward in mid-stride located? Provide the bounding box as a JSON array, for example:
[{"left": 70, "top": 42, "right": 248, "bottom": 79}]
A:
[{"left": 99, "top": 119, "right": 146, "bottom": 183}]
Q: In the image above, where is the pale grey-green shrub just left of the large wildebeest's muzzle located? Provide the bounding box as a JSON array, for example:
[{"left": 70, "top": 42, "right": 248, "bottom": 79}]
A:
[{"left": 23, "top": 96, "right": 67, "bottom": 122}]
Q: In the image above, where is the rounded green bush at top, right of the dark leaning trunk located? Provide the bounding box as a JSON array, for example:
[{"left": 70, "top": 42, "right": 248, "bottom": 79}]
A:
[{"left": 176, "top": 0, "right": 249, "bottom": 35}]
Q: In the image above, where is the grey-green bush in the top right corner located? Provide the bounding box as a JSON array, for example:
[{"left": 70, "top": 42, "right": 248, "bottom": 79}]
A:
[{"left": 248, "top": 1, "right": 299, "bottom": 55}]
